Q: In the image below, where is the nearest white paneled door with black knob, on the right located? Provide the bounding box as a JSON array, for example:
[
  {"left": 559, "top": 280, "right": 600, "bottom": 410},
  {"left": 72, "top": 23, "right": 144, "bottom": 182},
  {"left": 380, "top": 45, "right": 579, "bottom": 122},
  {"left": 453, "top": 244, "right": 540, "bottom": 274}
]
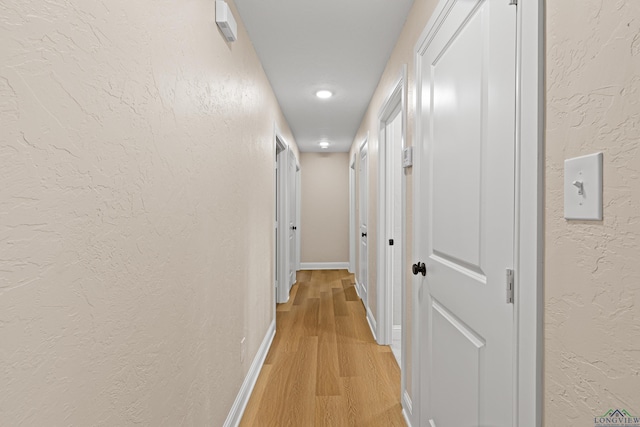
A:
[{"left": 414, "top": 0, "right": 516, "bottom": 427}]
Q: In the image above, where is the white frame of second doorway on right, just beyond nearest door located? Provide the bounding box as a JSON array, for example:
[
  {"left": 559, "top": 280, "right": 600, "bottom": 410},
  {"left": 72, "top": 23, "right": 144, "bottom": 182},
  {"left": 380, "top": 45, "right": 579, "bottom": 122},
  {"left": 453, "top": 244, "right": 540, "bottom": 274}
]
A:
[{"left": 376, "top": 65, "right": 407, "bottom": 352}]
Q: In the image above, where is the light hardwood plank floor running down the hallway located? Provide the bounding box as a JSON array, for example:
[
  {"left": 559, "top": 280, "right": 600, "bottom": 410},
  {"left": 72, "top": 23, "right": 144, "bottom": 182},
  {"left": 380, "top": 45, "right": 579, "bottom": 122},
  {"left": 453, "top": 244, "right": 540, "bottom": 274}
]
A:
[{"left": 240, "top": 270, "right": 406, "bottom": 427}]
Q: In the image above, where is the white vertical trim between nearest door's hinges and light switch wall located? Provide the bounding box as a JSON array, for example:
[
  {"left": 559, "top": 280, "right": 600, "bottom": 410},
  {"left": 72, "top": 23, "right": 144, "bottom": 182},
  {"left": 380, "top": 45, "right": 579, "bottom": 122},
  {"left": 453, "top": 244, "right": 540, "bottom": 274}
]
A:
[{"left": 514, "top": 0, "right": 545, "bottom": 427}]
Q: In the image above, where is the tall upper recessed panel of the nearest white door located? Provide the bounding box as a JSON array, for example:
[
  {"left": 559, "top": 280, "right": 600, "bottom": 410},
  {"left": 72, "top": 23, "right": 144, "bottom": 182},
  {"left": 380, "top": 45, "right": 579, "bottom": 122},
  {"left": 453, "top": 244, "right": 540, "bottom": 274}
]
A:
[{"left": 430, "top": 16, "right": 484, "bottom": 270}]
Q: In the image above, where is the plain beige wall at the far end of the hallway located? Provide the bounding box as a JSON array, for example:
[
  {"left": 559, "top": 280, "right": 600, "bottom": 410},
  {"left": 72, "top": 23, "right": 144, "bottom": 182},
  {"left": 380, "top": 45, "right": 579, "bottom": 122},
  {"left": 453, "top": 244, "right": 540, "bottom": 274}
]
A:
[{"left": 300, "top": 153, "right": 349, "bottom": 263}]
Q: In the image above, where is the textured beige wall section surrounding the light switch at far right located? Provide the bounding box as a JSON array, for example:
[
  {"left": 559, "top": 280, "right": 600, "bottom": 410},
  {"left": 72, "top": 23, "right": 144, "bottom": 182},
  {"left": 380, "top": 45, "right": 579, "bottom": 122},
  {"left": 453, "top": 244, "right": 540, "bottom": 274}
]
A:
[{"left": 544, "top": 0, "right": 640, "bottom": 427}]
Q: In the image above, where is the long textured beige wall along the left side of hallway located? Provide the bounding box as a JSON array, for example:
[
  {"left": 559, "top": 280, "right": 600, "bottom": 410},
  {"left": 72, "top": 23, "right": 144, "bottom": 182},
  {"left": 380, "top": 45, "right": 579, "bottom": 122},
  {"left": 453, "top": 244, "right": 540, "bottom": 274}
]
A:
[{"left": 0, "top": 0, "right": 294, "bottom": 426}]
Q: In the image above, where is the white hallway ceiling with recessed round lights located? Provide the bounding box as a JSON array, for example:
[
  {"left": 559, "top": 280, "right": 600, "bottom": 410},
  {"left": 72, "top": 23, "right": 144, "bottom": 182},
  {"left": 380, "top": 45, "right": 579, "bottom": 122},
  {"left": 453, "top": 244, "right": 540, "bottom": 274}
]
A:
[{"left": 235, "top": 0, "right": 413, "bottom": 152}]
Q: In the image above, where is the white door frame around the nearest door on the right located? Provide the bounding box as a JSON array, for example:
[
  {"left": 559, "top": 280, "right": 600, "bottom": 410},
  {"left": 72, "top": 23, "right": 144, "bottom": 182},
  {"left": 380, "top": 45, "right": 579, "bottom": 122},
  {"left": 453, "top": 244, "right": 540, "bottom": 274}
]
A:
[{"left": 410, "top": 0, "right": 544, "bottom": 427}]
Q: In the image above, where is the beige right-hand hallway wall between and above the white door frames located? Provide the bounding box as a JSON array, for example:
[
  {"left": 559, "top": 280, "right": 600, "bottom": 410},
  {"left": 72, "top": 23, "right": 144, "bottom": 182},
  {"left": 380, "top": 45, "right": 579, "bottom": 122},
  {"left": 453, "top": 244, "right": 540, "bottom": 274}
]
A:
[{"left": 351, "top": 0, "right": 438, "bottom": 404}]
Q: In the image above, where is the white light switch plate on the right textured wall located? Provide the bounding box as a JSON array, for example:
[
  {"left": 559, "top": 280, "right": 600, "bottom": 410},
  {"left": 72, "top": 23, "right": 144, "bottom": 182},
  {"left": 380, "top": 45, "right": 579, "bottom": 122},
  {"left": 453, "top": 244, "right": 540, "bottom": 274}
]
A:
[{"left": 564, "top": 153, "right": 602, "bottom": 221}]
